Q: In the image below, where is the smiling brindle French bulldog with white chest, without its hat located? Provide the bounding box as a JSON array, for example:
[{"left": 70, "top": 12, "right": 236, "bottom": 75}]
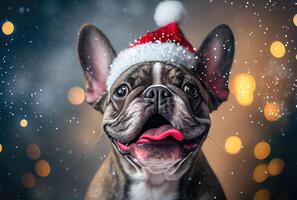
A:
[{"left": 78, "top": 24, "right": 234, "bottom": 200}]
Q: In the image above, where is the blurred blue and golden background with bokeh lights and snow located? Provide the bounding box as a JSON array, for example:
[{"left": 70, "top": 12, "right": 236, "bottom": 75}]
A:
[{"left": 0, "top": 0, "right": 297, "bottom": 200}]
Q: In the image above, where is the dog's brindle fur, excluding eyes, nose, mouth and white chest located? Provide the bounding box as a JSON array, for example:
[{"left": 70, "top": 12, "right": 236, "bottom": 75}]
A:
[{"left": 78, "top": 25, "right": 234, "bottom": 200}]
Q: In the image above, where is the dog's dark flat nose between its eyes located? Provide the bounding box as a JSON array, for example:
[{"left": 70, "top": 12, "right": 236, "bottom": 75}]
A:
[{"left": 144, "top": 85, "right": 172, "bottom": 101}]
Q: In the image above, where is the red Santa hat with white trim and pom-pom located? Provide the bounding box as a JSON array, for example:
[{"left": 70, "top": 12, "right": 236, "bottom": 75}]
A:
[{"left": 106, "top": 1, "right": 196, "bottom": 90}]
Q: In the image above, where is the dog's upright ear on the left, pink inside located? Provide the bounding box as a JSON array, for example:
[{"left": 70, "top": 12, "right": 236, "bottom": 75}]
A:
[{"left": 77, "top": 24, "right": 115, "bottom": 111}]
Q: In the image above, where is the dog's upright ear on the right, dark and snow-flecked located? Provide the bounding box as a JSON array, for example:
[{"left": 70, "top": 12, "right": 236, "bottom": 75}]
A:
[{"left": 196, "top": 25, "right": 234, "bottom": 112}]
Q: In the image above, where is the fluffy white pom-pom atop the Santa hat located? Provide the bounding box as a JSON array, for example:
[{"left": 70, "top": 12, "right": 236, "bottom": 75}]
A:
[{"left": 154, "top": 1, "right": 186, "bottom": 26}]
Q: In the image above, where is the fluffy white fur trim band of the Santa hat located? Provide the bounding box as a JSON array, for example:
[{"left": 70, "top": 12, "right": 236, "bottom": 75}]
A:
[{"left": 106, "top": 43, "right": 196, "bottom": 90}]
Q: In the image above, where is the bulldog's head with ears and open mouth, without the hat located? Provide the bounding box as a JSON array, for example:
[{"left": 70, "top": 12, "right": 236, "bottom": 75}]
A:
[{"left": 78, "top": 25, "right": 234, "bottom": 178}]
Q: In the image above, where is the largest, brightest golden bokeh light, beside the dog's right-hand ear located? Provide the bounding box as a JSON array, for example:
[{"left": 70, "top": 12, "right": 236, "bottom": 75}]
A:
[{"left": 231, "top": 73, "right": 256, "bottom": 106}]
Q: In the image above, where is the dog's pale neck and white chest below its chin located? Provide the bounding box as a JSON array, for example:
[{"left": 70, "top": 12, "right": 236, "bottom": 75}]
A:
[{"left": 114, "top": 148, "right": 191, "bottom": 200}]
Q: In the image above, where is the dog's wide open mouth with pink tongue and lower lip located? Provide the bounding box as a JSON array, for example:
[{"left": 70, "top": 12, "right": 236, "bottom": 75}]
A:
[{"left": 113, "top": 114, "right": 203, "bottom": 163}]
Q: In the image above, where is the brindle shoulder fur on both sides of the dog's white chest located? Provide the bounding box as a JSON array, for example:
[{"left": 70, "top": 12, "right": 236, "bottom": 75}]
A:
[{"left": 85, "top": 151, "right": 226, "bottom": 200}]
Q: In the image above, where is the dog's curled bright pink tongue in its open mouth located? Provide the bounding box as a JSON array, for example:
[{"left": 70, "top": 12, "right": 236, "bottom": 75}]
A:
[{"left": 136, "top": 125, "right": 183, "bottom": 144}]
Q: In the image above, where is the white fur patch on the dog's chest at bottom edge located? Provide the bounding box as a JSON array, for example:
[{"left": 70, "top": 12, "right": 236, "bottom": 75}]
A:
[{"left": 128, "top": 181, "right": 177, "bottom": 200}]
